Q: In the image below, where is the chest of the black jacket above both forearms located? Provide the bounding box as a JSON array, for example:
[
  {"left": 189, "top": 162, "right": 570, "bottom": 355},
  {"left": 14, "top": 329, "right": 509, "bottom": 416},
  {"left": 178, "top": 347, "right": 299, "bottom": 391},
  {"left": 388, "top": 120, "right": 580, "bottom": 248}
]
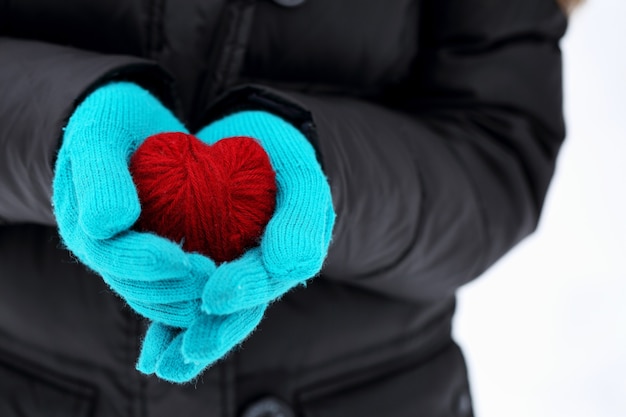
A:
[{"left": 0, "top": 0, "right": 421, "bottom": 129}]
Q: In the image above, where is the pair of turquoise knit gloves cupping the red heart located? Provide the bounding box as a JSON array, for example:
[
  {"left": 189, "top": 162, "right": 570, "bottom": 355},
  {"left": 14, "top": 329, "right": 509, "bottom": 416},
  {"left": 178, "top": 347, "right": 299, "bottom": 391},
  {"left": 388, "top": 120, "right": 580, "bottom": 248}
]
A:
[{"left": 52, "top": 82, "right": 335, "bottom": 383}]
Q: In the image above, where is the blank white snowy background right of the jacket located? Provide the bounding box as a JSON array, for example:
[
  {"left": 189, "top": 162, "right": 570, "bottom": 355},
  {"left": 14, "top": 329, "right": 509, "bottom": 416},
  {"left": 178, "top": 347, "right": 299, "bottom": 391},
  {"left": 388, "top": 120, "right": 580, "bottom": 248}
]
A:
[{"left": 455, "top": 0, "right": 626, "bottom": 417}]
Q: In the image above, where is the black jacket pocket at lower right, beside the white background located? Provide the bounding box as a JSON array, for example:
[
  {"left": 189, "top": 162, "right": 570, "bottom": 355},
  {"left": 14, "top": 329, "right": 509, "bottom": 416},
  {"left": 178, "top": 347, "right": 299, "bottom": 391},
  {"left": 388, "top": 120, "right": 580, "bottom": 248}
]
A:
[{"left": 300, "top": 343, "right": 473, "bottom": 417}]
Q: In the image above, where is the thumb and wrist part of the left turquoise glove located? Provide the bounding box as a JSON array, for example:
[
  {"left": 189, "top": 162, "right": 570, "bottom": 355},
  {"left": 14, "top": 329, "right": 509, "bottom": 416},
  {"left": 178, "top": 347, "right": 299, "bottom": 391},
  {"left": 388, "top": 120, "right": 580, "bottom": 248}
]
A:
[{"left": 57, "top": 82, "right": 185, "bottom": 239}]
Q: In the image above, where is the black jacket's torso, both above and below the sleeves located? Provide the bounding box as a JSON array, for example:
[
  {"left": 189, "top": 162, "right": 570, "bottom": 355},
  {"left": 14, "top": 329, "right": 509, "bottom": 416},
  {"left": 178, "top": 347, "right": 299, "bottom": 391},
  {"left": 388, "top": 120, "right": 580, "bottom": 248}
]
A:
[{"left": 0, "top": 0, "right": 470, "bottom": 417}]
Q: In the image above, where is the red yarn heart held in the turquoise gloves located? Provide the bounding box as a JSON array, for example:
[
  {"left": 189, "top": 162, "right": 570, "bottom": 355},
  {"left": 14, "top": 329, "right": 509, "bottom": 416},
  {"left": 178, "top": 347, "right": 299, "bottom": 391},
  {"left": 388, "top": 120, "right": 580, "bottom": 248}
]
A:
[{"left": 130, "top": 132, "right": 276, "bottom": 262}]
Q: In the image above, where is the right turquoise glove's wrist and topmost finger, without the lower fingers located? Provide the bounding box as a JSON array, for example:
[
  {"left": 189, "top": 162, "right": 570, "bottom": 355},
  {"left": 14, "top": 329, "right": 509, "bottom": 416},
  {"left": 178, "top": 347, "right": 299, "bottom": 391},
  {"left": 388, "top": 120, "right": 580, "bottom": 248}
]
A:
[{"left": 198, "top": 111, "right": 335, "bottom": 314}]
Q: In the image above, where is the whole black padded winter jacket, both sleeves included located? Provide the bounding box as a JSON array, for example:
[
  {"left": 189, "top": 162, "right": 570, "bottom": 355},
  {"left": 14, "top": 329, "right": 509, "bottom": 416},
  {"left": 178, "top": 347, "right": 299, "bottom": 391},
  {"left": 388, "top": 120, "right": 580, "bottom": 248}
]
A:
[{"left": 0, "top": 0, "right": 566, "bottom": 417}]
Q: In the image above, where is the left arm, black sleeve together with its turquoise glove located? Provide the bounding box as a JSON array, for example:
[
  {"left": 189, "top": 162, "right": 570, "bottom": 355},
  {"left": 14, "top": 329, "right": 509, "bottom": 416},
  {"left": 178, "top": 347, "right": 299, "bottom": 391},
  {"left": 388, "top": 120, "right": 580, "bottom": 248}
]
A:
[{"left": 0, "top": 37, "right": 214, "bottom": 380}]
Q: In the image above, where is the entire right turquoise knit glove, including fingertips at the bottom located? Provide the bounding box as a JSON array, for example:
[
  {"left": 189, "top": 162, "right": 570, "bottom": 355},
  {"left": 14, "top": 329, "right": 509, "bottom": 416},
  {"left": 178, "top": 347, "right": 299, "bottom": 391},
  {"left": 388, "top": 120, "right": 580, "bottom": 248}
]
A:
[{"left": 137, "top": 111, "right": 335, "bottom": 382}]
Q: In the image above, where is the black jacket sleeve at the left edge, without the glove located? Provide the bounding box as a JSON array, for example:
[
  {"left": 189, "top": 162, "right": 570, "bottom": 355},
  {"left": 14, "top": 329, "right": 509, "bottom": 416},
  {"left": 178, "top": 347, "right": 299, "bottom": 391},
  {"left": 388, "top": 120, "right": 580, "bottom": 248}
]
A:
[{"left": 0, "top": 36, "right": 174, "bottom": 225}]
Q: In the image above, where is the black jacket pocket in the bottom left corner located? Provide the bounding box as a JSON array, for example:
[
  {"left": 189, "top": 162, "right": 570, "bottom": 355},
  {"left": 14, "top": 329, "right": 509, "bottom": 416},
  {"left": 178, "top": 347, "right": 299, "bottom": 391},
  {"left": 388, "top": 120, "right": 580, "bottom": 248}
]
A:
[{"left": 0, "top": 351, "right": 95, "bottom": 417}]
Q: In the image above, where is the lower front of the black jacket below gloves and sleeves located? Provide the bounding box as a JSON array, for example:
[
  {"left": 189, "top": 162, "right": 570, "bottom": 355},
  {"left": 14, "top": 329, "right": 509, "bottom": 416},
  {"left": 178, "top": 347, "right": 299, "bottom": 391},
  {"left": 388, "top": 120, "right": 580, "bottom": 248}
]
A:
[{"left": 0, "top": 225, "right": 468, "bottom": 417}]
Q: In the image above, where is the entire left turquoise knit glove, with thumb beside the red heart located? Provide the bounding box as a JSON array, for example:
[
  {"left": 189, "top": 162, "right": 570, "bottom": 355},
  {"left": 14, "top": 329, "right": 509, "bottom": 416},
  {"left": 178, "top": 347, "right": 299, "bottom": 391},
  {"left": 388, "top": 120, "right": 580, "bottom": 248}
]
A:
[{"left": 52, "top": 82, "right": 205, "bottom": 326}]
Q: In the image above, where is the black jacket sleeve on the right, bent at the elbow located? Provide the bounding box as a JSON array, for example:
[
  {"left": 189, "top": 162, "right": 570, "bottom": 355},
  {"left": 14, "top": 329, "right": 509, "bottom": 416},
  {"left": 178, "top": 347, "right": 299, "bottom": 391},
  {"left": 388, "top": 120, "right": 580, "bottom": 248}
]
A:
[{"left": 202, "top": 0, "right": 567, "bottom": 300}]
